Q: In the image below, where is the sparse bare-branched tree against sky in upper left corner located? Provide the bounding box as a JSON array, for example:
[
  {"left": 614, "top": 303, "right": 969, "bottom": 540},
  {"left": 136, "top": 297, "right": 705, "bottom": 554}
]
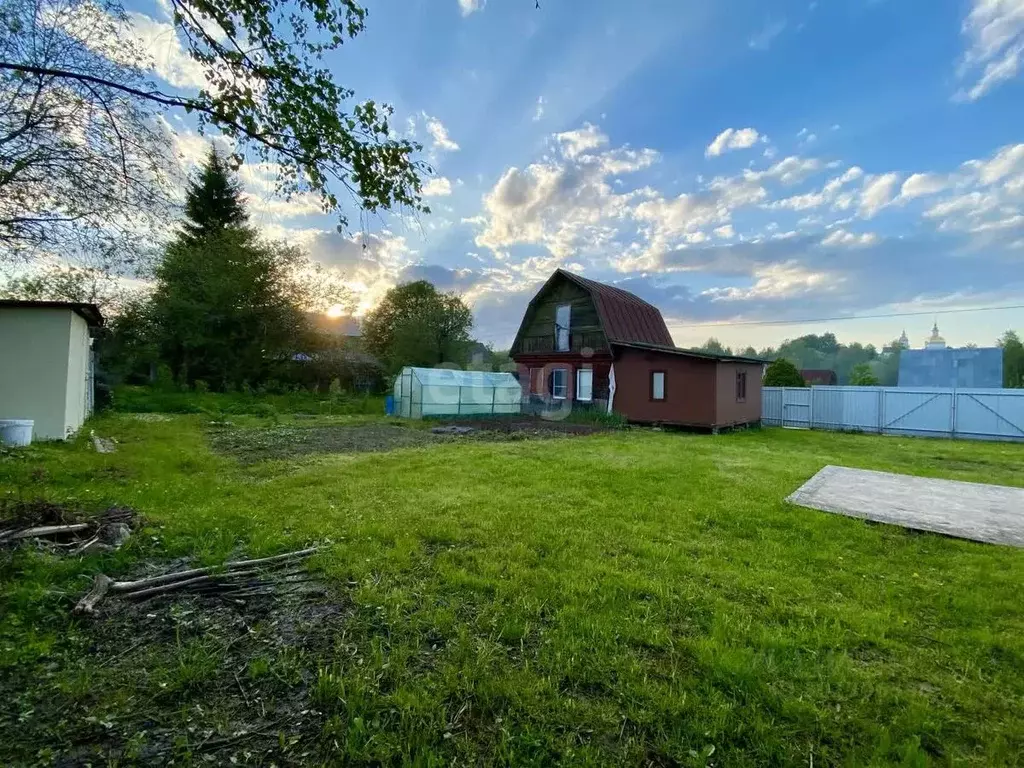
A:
[{"left": 0, "top": 0, "right": 169, "bottom": 268}]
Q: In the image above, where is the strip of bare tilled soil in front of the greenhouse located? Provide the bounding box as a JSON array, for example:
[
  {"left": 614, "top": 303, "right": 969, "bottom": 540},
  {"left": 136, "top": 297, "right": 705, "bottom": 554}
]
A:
[{"left": 209, "top": 419, "right": 608, "bottom": 464}]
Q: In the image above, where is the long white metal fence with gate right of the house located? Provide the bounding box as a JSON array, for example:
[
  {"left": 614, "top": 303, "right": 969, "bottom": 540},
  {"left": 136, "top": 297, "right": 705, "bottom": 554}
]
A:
[{"left": 761, "top": 387, "right": 1024, "bottom": 440}]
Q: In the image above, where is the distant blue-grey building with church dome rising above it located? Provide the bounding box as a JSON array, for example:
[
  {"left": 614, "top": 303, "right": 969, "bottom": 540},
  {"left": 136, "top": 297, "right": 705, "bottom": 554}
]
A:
[{"left": 898, "top": 323, "right": 1002, "bottom": 389}]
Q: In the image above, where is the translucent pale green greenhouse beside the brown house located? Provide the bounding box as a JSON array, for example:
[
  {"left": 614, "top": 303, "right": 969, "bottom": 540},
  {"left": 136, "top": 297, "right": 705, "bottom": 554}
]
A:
[{"left": 394, "top": 368, "right": 522, "bottom": 419}]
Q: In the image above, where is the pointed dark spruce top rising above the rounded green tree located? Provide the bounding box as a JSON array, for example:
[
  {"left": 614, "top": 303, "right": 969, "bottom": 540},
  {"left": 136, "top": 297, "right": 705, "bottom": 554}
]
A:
[{"left": 181, "top": 146, "right": 249, "bottom": 243}]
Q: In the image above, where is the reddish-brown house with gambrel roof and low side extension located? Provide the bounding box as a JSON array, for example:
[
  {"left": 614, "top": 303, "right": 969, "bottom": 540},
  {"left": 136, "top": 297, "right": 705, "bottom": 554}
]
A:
[{"left": 510, "top": 269, "right": 764, "bottom": 429}]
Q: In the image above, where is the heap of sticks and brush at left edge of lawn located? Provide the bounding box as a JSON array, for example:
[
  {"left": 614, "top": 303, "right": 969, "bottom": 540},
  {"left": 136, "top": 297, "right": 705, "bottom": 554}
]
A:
[{"left": 0, "top": 502, "right": 138, "bottom": 555}]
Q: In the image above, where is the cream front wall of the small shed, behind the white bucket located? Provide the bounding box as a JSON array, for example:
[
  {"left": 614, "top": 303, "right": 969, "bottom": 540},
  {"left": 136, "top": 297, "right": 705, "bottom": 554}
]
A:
[{"left": 0, "top": 307, "right": 72, "bottom": 440}]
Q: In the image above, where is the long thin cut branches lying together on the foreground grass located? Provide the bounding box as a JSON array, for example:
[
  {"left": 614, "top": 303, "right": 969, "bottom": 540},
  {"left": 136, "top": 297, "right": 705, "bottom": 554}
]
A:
[{"left": 75, "top": 547, "right": 316, "bottom": 615}]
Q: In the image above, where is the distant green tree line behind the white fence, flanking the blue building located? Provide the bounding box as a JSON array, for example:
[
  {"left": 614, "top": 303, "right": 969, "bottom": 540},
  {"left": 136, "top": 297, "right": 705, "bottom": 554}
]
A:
[{"left": 693, "top": 331, "right": 1024, "bottom": 387}]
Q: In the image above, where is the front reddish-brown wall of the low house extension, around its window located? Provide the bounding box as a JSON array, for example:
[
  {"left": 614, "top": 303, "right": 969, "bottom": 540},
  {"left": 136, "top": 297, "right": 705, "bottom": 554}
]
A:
[{"left": 612, "top": 347, "right": 716, "bottom": 427}]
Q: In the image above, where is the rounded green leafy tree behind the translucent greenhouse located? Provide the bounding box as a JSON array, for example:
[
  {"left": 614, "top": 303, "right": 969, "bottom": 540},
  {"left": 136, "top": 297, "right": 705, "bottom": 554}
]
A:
[{"left": 362, "top": 281, "right": 473, "bottom": 372}]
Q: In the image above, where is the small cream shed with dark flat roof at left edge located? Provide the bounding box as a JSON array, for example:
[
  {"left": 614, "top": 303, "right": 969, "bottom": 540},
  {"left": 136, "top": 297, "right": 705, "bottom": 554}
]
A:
[{"left": 0, "top": 300, "right": 103, "bottom": 440}]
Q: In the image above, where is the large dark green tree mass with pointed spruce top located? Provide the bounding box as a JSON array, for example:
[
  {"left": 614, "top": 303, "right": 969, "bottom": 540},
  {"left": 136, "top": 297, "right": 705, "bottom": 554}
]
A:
[{"left": 148, "top": 153, "right": 346, "bottom": 388}]
